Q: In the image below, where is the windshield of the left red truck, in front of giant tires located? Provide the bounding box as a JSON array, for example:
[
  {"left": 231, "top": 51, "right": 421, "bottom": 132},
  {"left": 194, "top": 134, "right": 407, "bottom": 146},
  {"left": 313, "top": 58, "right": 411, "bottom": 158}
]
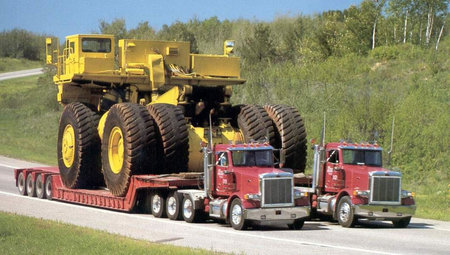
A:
[{"left": 231, "top": 150, "right": 273, "bottom": 166}]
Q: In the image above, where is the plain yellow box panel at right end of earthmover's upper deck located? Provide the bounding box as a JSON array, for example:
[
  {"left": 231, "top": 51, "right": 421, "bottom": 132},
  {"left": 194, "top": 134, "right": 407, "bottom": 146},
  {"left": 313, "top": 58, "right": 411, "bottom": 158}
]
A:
[{"left": 191, "top": 54, "right": 241, "bottom": 78}]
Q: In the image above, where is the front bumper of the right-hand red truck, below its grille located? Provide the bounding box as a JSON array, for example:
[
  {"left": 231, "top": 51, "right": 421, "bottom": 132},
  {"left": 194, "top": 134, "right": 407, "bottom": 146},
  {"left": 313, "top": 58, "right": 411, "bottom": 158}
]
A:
[{"left": 353, "top": 205, "right": 416, "bottom": 220}]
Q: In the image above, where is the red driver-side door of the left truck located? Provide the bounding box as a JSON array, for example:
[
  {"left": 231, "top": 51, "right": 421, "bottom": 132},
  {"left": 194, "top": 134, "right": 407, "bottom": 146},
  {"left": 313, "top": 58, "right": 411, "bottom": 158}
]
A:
[{"left": 215, "top": 151, "right": 236, "bottom": 195}]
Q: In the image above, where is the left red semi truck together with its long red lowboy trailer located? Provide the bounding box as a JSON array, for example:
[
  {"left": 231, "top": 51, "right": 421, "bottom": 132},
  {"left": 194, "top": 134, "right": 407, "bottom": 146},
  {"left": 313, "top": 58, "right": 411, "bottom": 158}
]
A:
[{"left": 15, "top": 144, "right": 311, "bottom": 230}]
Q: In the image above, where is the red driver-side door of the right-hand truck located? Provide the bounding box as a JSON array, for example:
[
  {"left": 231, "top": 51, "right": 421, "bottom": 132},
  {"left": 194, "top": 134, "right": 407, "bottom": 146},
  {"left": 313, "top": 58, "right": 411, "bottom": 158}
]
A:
[{"left": 325, "top": 149, "right": 345, "bottom": 192}]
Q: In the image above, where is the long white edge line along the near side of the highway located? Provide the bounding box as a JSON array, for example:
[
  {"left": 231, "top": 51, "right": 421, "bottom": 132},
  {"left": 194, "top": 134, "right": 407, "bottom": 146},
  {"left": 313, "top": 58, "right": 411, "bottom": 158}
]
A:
[{"left": 0, "top": 191, "right": 392, "bottom": 254}]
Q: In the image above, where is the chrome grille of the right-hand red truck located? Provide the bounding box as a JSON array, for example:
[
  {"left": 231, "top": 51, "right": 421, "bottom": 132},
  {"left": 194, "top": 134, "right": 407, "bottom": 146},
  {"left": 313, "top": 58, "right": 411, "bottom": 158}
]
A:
[{"left": 370, "top": 176, "right": 401, "bottom": 204}]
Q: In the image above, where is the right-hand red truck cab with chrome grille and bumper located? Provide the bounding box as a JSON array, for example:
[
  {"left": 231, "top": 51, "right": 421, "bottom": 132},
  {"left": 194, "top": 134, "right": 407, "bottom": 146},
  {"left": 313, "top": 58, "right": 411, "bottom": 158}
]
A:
[{"left": 313, "top": 142, "right": 416, "bottom": 227}]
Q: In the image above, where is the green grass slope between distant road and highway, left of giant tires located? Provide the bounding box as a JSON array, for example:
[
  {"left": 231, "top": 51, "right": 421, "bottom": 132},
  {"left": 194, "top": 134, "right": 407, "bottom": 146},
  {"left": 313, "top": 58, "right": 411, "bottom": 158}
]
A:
[{"left": 0, "top": 75, "right": 61, "bottom": 164}]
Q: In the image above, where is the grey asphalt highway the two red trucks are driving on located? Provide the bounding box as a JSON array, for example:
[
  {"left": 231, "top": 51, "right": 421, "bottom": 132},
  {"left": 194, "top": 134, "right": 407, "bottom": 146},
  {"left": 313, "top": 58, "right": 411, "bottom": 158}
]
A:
[{"left": 0, "top": 156, "right": 450, "bottom": 255}]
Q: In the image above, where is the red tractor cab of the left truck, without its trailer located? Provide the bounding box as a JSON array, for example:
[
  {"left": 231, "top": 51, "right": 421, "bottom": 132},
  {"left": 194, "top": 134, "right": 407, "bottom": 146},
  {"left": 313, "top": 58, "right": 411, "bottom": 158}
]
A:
[{"left": 179, "top": 144, "right": 310, "bottom": 230}]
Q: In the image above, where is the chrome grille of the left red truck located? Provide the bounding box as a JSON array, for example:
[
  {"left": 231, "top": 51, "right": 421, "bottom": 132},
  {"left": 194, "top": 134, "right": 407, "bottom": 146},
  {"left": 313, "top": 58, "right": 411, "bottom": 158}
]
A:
[{"left": 262, "top": 177, "right": 294, "bottom": 207}]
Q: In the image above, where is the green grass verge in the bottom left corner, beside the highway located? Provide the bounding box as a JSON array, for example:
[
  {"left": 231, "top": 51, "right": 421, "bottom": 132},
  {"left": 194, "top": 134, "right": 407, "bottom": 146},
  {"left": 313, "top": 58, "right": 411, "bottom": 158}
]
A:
[{"left": 0, "top": 212, "right": 222, "bottom": 255}]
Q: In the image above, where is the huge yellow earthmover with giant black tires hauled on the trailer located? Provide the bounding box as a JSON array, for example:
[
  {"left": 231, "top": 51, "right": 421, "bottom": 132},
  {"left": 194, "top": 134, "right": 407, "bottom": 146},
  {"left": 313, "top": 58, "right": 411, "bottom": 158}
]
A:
[{"left": 46, "top": 34, "right": 306, "bottom": 196}]
